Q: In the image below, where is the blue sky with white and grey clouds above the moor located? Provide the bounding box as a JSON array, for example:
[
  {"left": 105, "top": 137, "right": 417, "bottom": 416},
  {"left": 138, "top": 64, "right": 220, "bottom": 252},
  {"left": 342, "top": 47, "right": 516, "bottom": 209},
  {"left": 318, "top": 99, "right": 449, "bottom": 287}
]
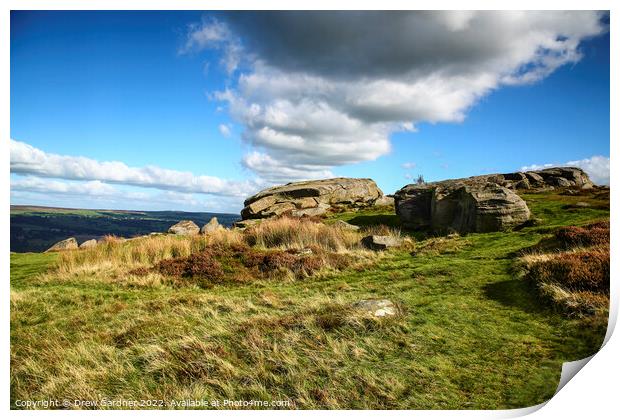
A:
[{"left": 10, "top": 11, "right": 610, "bottom": 213}]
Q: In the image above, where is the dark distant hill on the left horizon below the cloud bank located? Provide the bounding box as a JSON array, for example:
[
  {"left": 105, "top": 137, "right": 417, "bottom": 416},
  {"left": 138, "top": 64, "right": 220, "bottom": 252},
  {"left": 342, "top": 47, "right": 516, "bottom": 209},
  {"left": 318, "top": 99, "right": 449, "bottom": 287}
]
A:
[{"left": 11, "top": 205, "right": 240, "bottom": 252}]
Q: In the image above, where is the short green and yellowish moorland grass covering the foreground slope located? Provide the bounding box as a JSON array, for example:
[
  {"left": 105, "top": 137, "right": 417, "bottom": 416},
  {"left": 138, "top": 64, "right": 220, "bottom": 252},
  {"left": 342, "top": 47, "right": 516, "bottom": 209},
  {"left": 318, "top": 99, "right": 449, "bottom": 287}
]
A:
[{"left": 11, "top": 189, "right": 609, "bottom": 409}]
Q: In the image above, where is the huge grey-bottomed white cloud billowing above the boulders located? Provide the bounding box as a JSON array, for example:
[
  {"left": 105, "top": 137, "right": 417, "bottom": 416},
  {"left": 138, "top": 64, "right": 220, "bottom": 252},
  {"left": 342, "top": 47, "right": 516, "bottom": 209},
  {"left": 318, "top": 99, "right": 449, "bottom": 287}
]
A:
[{"left": 183, "top": 11, "right": 606, "bottom": 182}]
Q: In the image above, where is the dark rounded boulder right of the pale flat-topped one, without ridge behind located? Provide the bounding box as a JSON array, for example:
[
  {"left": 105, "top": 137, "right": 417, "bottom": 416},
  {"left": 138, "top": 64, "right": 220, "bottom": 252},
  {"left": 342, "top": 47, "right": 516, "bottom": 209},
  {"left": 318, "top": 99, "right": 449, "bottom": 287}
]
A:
[{"left": 396, "top": 180, "right": 530, "bottom": 233}]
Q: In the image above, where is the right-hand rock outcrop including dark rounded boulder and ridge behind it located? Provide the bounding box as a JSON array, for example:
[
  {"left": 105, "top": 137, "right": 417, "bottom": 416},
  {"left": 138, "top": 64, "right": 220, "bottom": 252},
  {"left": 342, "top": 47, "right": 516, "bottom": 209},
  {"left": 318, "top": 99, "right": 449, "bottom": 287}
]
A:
[{"left": 395, "top": 168, "right": 594, "bottom": 233}]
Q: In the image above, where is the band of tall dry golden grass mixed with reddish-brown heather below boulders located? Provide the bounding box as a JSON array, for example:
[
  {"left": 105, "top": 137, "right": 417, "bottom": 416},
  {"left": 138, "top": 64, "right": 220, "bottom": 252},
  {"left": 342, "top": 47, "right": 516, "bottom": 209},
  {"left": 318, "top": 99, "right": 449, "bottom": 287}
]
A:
[{"left": 39, "top": 217, "right": 392, "bottom": 287}]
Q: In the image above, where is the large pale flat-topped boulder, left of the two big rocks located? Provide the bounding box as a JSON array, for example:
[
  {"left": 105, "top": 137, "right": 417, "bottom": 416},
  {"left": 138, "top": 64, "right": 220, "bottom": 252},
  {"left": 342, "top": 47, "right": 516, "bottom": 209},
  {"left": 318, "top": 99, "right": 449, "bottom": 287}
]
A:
[{"left": 241, "top": 178, "right": 383, "bottom": 219}]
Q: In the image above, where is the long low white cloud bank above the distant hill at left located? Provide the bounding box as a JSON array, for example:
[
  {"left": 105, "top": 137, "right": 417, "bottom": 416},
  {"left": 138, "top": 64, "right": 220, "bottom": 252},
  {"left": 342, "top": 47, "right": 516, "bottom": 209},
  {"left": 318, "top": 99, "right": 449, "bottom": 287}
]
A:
[{"left": 10, "top": 139, "right": 261, "bottom": 197}]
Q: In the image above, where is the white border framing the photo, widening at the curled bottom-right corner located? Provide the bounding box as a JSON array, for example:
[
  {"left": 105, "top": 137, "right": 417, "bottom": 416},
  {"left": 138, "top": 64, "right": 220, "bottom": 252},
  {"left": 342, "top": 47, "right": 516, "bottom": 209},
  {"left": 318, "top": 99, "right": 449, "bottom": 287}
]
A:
[{"left": 0, "top": 0, "right": 620, "bottom": 420}]
